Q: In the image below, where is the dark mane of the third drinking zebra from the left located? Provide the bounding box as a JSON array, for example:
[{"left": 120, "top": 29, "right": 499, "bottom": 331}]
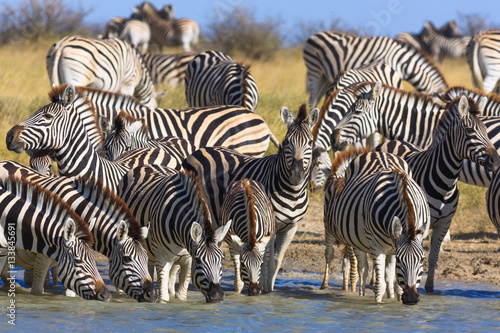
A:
[{"left": 179, "top": 170, "right": 215, "bottom": 243}]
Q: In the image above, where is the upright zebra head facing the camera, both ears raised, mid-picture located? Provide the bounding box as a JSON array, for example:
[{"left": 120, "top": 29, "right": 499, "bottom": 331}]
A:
[{"left": 280, "top": 104, "right": 319, "bottom": 186}]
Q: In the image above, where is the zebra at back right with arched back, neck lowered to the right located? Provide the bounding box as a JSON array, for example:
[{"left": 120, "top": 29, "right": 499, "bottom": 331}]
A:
[{"left": 303, "top": 31, "right": 447, "bottom": 106}]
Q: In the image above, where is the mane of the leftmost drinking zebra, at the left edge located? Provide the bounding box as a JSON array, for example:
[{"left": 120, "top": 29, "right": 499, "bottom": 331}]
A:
[{"left": 0, "top": 175, "right": 94, "bottom": 246}]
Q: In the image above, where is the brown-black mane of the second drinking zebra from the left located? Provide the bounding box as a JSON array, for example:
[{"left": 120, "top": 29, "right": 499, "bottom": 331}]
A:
[{"left": 73, "top": 177, "right": 144, "bottom": 242}]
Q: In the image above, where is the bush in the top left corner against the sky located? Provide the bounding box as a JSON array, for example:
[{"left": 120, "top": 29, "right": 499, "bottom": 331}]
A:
[{"left": 0, "top": 0, "right": 92, "bottom": 44}]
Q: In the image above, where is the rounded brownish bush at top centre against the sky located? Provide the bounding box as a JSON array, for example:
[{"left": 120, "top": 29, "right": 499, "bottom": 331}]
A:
[{"left": 204, "top": 7, "right": 283, "bottom": 60}]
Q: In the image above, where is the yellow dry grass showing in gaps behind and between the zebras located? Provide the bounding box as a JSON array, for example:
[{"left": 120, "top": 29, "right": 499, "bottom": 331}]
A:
[{"left": 0, "top": 40, "right": 496, "bottom": 235}]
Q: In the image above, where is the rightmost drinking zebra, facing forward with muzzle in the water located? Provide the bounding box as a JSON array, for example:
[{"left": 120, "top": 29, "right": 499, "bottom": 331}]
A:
[{"left": 322, "top": 149, "right": 430, "bottom": 305}]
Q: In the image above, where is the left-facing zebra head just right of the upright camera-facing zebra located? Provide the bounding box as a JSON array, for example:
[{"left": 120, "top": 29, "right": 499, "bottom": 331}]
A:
[{"left": 331, "top": 81, "right": 382, "bottom": 150}]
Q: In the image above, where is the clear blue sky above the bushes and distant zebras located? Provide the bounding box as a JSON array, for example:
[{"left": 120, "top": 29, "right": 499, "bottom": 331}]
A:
[{"left": 78, "top": 0, "right": 500, "bottom": 37}]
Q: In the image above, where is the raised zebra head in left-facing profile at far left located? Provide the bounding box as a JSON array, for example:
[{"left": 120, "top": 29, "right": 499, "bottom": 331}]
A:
[{"left": 6, "top": 84, "right": 95, "bottom": 153}]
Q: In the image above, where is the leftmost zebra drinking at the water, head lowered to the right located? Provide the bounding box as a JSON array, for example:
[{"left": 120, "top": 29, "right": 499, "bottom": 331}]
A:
[{"left": 0, "top": 177, "right": 111, "bottom": 302}]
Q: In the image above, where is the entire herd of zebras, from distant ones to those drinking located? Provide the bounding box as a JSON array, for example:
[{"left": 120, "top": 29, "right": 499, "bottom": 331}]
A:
[{"left": 0, "top": 11, "right": 500, "bottom": 305}]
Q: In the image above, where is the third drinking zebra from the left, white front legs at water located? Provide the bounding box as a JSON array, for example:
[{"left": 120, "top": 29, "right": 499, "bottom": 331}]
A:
[{"left": 118, "top": 165, "right": 231, "bottom": 302}]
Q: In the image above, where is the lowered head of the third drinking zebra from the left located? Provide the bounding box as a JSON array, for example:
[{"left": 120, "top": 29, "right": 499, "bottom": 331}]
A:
[{"left": 190, "top": 220, "right": 232, "bottom": 303}]
